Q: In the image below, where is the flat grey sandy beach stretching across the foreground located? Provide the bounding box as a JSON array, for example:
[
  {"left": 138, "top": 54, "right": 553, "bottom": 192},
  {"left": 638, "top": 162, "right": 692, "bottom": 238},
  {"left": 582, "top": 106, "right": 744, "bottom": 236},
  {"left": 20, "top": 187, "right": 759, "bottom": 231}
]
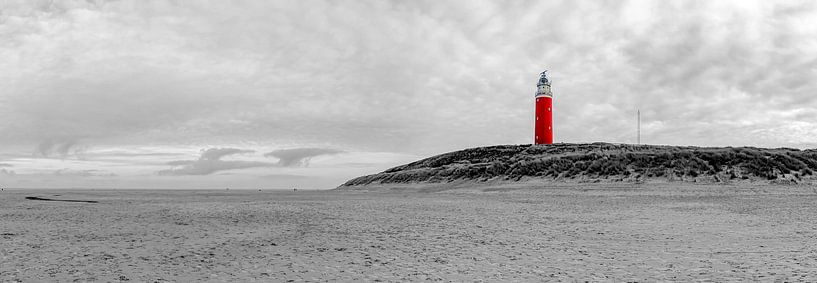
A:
[{"left": 0, "top": 184, "right": 817, "bottom": 282}]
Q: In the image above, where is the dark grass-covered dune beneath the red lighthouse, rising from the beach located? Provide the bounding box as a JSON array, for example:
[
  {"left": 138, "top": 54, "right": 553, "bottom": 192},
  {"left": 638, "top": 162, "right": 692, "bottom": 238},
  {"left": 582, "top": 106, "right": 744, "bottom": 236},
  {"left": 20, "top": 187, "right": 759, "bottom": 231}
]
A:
[{"left": 341, "top": 143, "right": 817, "bottom": 188}]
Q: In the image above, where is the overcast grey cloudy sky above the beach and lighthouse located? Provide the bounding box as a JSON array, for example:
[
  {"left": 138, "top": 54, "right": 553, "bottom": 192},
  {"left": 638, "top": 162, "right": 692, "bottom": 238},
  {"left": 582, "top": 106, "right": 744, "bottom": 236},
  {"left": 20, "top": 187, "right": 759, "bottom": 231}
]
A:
[{"left": 0, "top": 0, "right": 817, "bottom": 189}]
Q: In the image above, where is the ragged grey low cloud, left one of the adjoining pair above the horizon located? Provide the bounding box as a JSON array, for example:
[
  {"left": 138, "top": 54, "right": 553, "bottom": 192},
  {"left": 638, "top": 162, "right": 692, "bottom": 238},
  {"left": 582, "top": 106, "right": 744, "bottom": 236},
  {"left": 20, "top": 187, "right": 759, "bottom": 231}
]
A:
[{"left": 157, "top": 148, "right": 275, "bottom": 176}]
